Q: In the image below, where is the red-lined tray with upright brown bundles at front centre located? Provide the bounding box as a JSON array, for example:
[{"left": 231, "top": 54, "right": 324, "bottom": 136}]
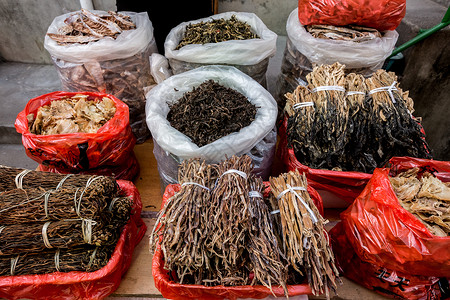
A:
[{"left": 150, "top": 155, "right": 338, "bottom": 299}]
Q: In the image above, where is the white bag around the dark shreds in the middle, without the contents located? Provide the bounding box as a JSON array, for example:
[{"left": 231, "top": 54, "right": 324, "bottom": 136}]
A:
[{"left": 146, "top": 65, "right": 277, "bottom": 185}]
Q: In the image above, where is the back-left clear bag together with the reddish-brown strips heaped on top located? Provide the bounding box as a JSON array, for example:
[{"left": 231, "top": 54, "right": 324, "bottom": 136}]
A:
[{"left": 44, "top": 9, "right": 157, "bottom": 143}]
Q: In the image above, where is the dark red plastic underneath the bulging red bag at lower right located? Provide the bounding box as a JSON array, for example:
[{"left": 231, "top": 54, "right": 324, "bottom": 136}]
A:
[{"left": 330, "top": 223, "right": 442, "bottom": 299}]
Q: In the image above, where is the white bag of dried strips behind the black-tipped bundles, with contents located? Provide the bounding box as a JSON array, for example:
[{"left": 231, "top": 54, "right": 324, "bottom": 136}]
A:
[{"left": 276, "top": 8, "right": 398, "bottom": 120}]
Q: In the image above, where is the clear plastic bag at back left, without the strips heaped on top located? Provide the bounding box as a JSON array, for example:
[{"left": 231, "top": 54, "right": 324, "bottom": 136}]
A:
[{"left": 44, "top": 11, "right": 157, "bottom": 143}]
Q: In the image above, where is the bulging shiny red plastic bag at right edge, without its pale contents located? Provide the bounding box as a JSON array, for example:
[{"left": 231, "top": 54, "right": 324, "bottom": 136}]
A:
[{"left": 341, "top": 158, "right": 450, "bottom": 278}]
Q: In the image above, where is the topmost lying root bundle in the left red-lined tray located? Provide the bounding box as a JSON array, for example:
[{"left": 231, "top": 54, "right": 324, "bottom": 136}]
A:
[{"left": 0, "top": 166, "right": 118, "bottom": 192}]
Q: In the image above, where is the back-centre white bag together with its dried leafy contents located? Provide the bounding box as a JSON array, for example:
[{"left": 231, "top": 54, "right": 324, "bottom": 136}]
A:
[{"left": 164, "top": 12, "right": 277, "bottom": 86}]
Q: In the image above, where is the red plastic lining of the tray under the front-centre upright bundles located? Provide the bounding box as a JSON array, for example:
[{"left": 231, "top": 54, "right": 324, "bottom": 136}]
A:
[{"left": 152, "top": 182, "right": 323, "bottom": 300}]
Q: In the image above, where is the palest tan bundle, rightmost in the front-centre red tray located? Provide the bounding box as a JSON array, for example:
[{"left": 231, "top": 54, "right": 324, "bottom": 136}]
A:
[{"left": 270, "top": 171, "right": 339, "bottom": 299}]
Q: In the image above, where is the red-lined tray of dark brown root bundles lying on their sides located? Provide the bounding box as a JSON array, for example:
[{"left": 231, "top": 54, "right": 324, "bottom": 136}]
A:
[{"left": 0, "top": 166, "right": 146, "bottom": 299}]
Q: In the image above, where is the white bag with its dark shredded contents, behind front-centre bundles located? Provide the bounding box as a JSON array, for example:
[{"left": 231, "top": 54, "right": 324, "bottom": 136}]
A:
[{"left": 146, "top": 66, "right": 277, "bottom": 187}]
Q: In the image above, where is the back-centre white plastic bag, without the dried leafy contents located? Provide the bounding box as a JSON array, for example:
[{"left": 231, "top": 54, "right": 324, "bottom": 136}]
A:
[{"left": 164, "top": 12, "right": 277, "bottom": 86}]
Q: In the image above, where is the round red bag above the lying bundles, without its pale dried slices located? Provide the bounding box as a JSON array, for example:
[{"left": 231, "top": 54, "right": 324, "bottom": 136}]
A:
[{"left": 15, "top": 92, "right": 136, "bottom": 180}]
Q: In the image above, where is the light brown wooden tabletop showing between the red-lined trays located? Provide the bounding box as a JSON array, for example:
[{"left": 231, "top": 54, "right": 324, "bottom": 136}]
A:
[{"left": 109, "top": 140, "right": 388, "bottom": 300}]
